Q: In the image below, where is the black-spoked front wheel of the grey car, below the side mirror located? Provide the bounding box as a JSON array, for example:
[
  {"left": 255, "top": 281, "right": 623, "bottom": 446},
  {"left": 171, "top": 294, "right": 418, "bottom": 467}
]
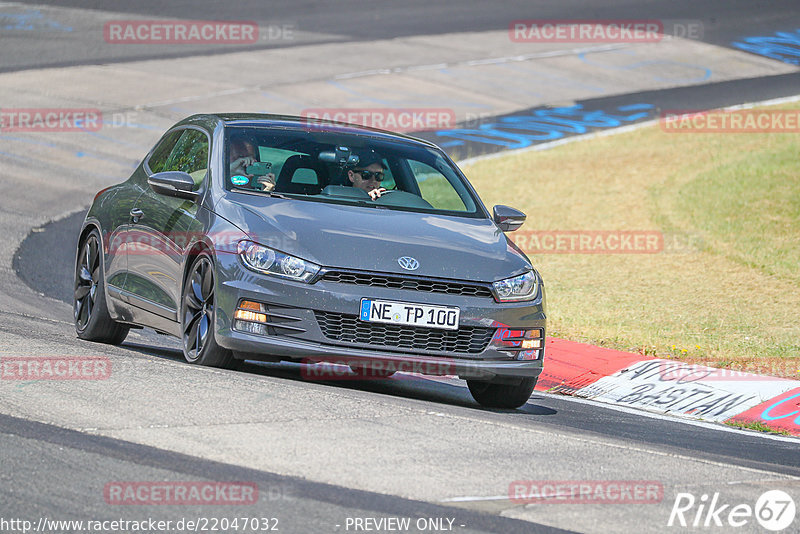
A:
[{"left": 181, "top": 252, "right": 236, "bottom": 369}]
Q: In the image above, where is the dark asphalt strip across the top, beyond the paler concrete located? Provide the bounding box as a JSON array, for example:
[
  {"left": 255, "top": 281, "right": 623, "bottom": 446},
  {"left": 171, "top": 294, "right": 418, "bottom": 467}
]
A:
[{"left": 0, "top": 0, "right": 800, "bottom": 72}]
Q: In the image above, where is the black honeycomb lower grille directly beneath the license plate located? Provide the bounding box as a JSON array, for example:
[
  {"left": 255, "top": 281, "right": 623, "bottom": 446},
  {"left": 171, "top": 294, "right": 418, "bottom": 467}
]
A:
[{"left": 314, "top": 311, "right": 495, "bottom": 354}]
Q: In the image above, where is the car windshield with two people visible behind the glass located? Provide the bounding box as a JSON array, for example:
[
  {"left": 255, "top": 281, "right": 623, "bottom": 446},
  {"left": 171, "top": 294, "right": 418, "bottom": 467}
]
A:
[{"left": 225, "top": 127, "right": 483, "bottom": 217}]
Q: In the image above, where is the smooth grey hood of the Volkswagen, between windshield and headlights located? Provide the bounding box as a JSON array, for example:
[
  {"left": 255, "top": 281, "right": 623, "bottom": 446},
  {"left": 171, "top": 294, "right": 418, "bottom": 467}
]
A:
[{"left": 215, "top": 195, "right": 530, "bottom": 282}]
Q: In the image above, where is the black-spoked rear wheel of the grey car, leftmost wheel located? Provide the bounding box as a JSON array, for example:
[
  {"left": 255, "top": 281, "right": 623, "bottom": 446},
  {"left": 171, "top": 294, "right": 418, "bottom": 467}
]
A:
[{"left": 72, "top": 229, "right": 129, "bottom": 345}]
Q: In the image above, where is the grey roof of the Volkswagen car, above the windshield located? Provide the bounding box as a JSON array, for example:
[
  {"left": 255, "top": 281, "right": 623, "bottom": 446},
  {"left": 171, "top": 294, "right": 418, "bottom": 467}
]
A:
[{"left": 175, "top": 113, "right": 438, "bottom": 148}]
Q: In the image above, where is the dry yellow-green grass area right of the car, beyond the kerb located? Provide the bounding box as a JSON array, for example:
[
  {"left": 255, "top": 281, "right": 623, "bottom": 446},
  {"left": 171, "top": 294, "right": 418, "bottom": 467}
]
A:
[{"left": 464, "top": 104, "right": 800, "bottom": 379}]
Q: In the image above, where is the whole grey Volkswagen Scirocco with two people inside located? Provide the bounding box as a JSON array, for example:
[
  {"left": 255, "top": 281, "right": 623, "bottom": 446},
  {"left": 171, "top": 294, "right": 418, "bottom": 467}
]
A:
[{"left": 74, "top": 114, "right": 546, "bottom": 408}]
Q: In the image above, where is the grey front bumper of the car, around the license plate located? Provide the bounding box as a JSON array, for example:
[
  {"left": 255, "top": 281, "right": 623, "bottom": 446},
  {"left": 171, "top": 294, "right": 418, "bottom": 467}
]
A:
[{"left": 215, "top": 254, "right": 546, "bottom": 380}]
